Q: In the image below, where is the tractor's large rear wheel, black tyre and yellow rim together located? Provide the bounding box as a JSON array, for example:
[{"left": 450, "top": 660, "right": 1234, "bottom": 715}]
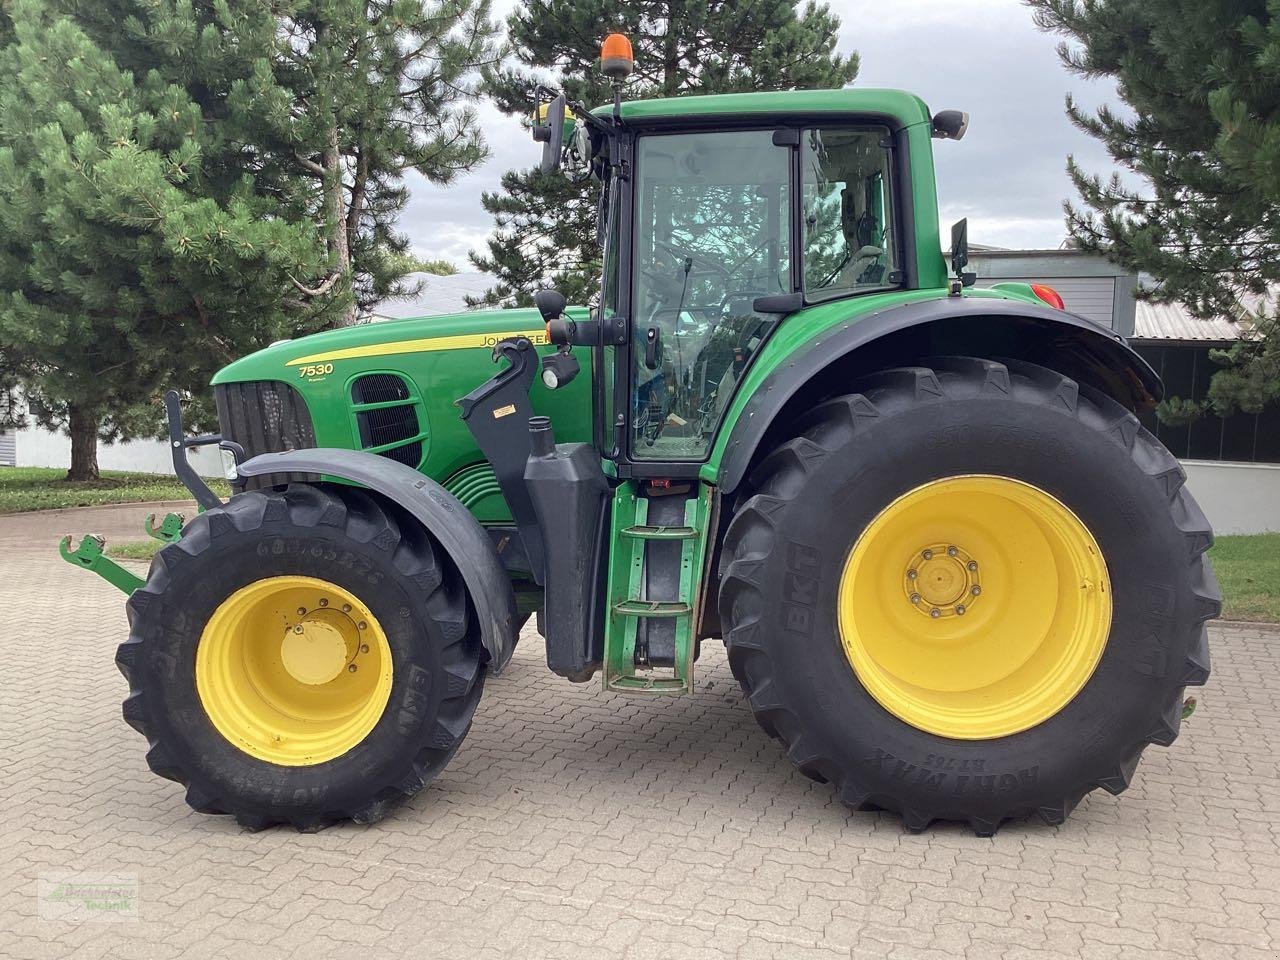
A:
[{"left": 719, "top": 357, "right": 1219, "bottom": 835}]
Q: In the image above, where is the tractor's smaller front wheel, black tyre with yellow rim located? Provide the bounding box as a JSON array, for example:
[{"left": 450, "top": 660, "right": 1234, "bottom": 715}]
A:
[{"left": 116, "top": 485, "right": 484, "bottom": 829}]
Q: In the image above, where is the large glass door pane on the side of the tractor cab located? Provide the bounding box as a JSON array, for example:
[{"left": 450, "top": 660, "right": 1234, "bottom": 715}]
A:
[{"left": 632, "top": 131, "right": 792, "bottom": 460}]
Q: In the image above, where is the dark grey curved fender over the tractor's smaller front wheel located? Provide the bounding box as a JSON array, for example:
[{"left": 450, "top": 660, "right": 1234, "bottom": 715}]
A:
[{"left": 237, "top": 447, "right": 517, "bottom": 673}]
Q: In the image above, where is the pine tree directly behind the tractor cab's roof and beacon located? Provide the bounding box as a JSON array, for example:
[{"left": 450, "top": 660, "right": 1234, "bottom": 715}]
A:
[{"left": 471, "top": 0, "right": 858, "bottom": 306}]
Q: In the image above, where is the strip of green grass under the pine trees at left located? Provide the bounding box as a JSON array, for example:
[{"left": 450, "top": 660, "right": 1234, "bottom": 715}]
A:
[{"left": 0, "top": 467, "right": 230, "bottom": 513}]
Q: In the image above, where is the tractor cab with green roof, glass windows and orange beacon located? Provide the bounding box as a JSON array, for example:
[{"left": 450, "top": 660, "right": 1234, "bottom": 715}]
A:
[{"left": 532, "top": 35, "right": 966, "bottom": 476}]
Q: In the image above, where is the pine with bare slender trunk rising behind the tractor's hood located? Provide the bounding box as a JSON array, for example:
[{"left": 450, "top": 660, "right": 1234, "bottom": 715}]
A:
[{"left": 252, "top": 0, "right": 497, "bottom": 324}]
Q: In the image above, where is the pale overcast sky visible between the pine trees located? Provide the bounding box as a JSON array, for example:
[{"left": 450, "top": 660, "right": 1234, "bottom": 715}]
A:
[{"left": 401, "top": 0, "right": 1115, "bottom": 270}]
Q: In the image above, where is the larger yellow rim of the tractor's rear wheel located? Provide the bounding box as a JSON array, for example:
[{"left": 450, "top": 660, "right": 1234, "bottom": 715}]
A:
[{"left": 838, "top": 476, "right": 1111, "bottom": 740}]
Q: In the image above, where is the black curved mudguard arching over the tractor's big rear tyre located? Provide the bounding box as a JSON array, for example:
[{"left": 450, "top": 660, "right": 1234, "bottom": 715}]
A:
[{"left": 717, "top": 297, "right": 1164, "bottom": 494}]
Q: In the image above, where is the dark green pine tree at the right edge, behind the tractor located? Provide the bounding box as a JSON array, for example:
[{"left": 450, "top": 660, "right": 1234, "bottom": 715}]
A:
[{"left": 1028, "top": 0, "right": 1280, "bottom": 420}]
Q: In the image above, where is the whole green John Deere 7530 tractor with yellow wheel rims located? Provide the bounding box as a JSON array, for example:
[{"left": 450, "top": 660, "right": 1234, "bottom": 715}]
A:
[{"left": 67, "top": 36, "right": 1220, "bottom": 835}]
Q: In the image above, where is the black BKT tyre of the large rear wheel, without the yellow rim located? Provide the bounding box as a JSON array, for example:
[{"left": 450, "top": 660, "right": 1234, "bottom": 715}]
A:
[{"left": 719, "top": 357, "right": 1220, "bottom": 836}]
